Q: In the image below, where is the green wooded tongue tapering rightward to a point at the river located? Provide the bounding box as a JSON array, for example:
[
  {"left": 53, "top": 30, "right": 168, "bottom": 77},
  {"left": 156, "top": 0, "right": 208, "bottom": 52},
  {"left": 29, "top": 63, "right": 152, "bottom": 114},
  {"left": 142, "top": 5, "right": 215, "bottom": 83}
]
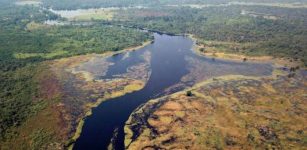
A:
[{"left": 0, "top": 18, "right": 150, "bottom": 71}]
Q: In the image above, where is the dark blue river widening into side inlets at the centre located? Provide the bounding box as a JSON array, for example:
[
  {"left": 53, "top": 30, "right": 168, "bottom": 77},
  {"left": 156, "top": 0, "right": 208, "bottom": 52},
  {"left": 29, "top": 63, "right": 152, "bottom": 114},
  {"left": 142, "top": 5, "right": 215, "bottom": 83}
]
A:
[{"left": 74, "top": 34, "right": 272, "bottom": 150}]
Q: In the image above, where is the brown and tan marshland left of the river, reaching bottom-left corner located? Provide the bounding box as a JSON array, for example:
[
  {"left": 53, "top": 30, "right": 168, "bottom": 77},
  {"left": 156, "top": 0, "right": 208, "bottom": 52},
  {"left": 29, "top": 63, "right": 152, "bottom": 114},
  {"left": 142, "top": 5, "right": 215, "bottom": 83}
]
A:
[{"left": 1, "top": 46, "right": 151, "bottom": 149}]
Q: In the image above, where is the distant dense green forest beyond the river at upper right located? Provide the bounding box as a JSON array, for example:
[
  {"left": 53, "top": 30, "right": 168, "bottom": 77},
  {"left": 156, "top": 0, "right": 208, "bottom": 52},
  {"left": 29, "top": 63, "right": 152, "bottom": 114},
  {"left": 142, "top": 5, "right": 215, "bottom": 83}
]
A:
[{"left": 110, "top": 6, "right": 307, "bottom": 65}]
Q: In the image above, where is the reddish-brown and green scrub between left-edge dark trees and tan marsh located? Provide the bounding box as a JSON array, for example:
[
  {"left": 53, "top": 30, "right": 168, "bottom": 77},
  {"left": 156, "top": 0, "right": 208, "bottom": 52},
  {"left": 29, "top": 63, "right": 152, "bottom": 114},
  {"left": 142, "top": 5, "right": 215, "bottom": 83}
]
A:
[{"left": 0, "top": 63, "right": 68, "bottom": 150}]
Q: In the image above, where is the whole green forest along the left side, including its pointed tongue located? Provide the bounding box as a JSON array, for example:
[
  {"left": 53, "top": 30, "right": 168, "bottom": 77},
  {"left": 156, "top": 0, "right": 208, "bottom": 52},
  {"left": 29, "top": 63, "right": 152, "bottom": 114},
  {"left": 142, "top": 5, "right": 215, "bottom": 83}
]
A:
[{"left": 0, "top": 2, "right": 152, "bottom": 141}]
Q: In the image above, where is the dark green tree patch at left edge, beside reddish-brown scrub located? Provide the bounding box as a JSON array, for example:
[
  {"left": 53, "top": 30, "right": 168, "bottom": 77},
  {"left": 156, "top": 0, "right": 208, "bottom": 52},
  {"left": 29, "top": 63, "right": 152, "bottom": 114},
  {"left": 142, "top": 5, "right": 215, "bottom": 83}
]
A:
[{"left": 0, "top": 65, "right": 46, "bottom": 139}]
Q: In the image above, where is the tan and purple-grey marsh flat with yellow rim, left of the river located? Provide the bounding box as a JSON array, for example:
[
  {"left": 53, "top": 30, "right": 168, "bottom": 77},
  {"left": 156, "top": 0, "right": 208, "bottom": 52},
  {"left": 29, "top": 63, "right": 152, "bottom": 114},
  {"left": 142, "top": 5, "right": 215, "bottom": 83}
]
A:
[{"left": 48, "top": 50, "right": 150, "bottom": 146}]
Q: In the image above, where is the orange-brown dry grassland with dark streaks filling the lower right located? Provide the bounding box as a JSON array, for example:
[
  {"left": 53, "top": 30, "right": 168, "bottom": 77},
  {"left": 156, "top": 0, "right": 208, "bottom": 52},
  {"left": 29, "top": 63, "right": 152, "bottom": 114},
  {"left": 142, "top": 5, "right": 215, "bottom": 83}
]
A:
[{"left": 125, "top": 71, "right": 307, "bottom": 149}]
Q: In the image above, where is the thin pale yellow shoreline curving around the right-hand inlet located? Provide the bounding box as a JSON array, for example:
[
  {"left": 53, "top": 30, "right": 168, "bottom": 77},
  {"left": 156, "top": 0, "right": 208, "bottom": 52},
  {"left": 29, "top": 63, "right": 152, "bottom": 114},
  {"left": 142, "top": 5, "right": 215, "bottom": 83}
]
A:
[{"left": 124, "top": 44, "right": 303, "bottom": 148}]
